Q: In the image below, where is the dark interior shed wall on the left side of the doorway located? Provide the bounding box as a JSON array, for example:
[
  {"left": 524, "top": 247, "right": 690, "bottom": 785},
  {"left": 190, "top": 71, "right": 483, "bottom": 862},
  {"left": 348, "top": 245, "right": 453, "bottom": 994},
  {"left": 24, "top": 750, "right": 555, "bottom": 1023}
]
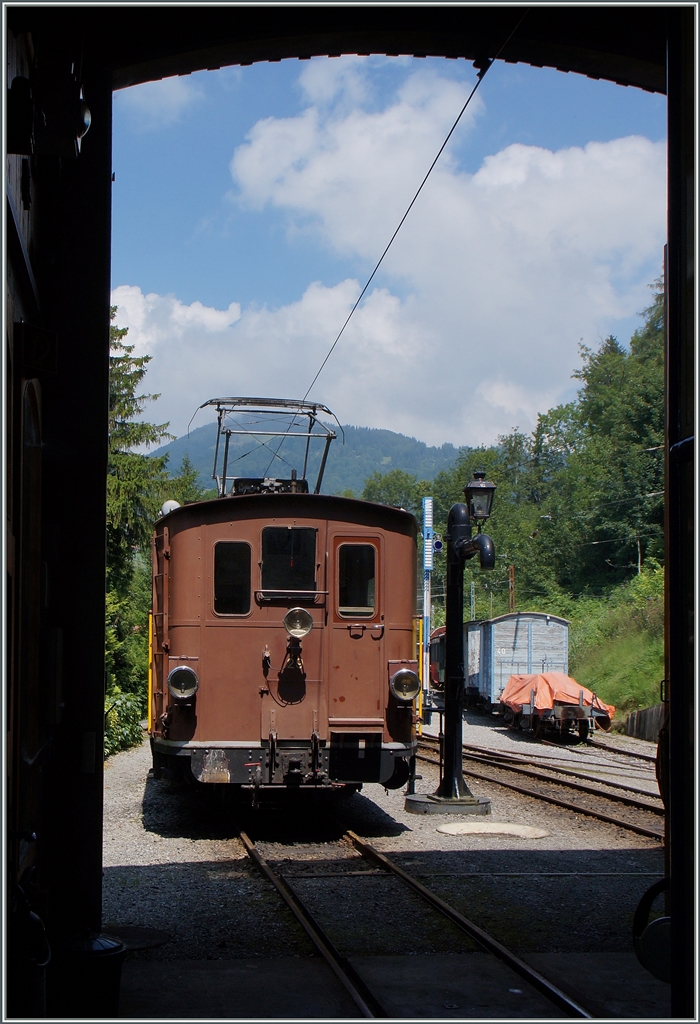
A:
[{"left": 5, "top": 16, "right": 112, "bottom": 1017}]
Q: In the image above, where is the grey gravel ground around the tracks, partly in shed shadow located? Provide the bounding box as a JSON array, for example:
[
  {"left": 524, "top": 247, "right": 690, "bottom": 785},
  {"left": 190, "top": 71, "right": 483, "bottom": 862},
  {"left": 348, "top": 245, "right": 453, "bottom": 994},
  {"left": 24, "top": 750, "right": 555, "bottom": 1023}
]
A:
[{"left": 103, "top": 716, "right": 663, "bottom": 959}]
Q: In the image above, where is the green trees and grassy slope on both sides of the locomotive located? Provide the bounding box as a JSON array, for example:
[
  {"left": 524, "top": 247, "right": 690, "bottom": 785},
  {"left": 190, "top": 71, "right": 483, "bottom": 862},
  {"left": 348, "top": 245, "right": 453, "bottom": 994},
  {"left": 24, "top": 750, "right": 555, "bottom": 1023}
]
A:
[{"left": 105, "top": 281, "right": 664, "bottom": 755}]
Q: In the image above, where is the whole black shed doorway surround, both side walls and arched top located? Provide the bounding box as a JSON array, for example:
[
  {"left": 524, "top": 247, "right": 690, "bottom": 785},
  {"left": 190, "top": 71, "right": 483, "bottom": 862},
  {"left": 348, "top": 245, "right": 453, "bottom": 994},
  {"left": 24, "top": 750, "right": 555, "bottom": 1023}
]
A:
[{"left": 6, "top": 5, "right": 695, "bottom": 1016}]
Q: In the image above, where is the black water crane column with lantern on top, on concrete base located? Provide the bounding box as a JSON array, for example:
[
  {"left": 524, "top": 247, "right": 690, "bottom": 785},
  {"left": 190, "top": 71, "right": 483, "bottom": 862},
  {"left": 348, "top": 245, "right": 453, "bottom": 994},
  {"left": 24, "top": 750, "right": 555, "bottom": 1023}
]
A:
[{"left": 405, "top": 472, "right": 495, "bottom": 814}]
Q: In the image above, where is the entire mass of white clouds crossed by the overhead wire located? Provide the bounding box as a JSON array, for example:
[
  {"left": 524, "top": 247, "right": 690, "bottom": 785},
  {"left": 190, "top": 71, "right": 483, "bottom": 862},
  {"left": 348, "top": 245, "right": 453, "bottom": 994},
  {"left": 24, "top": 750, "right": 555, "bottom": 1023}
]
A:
[{"left": 113, "top": 58, "right": 665, "bottom": 444}]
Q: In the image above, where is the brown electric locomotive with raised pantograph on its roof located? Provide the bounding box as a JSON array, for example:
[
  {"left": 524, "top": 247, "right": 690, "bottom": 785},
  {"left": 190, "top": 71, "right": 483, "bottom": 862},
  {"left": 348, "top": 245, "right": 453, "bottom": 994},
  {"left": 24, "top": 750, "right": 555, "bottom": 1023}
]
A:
[{"left": 148, "top": 399, "right": 420, "bottom": 797}]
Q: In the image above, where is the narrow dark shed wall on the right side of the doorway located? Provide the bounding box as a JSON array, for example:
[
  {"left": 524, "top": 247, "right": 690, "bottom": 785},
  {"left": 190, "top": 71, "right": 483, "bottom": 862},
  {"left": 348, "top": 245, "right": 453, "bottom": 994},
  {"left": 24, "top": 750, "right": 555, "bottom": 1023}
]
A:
[{"left": 665, "top": 8, "right": 697, "bottom": 1017}]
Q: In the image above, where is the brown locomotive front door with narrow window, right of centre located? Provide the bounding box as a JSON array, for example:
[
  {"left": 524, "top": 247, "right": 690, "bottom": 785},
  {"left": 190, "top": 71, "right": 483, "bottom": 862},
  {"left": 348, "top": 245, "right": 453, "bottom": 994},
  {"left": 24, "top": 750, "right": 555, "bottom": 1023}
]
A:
[{"left": 327, "top": 535, "right": 387, "bottom": 732}]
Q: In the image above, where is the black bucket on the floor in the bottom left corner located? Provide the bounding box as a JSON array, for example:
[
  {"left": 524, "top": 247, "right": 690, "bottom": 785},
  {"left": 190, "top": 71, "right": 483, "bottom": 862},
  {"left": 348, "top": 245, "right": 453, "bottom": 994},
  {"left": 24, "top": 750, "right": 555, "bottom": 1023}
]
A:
[{"left": 46, "top": 932, "right": 127, "bottom": 1020}]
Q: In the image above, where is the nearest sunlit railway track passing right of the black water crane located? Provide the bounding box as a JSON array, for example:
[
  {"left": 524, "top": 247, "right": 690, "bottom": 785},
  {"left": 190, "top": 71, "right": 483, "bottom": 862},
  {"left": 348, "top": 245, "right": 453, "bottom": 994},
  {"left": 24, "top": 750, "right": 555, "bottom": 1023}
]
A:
[{"left": 418, "top": 738, "right": 664, "bottom": 843}]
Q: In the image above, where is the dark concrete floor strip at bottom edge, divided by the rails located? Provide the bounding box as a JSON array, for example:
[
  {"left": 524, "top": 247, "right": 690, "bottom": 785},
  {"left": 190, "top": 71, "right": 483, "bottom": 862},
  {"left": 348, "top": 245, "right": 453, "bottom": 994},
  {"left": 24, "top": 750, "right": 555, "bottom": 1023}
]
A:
[{"left": 119, "top": 952, "right": 670, "bottom": 1020}]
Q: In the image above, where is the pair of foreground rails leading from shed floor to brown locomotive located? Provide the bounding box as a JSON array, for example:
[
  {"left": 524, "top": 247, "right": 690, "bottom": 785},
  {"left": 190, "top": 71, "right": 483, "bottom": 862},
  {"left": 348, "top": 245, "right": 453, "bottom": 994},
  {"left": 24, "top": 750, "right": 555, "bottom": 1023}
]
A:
[{"left": 240, "top": 831, "right": 592, "bottom": 1020}]
